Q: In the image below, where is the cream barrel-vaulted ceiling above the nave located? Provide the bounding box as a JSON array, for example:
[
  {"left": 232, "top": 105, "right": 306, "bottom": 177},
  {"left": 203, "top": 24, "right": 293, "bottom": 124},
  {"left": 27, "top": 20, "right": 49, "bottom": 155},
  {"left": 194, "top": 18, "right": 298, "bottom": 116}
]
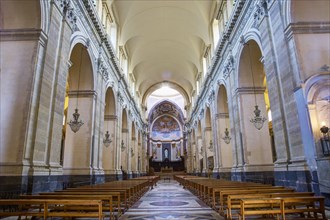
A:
[{"left": 113, "top": 0, "right": 215, "bottom": 104}]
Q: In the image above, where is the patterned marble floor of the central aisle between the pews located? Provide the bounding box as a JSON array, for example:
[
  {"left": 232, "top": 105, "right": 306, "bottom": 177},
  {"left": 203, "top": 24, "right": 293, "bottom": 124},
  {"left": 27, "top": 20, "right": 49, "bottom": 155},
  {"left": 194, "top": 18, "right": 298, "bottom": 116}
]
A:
[{"left": 119, "top": 180, "right": 224, "bottom": 220}]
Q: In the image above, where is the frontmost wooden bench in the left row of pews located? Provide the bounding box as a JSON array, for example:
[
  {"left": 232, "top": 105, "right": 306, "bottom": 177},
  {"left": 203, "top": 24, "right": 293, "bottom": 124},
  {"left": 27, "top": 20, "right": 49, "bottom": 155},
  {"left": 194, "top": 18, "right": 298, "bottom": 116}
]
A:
[{"left": 0, "top": 199, "right": 104, "bottom": 220}]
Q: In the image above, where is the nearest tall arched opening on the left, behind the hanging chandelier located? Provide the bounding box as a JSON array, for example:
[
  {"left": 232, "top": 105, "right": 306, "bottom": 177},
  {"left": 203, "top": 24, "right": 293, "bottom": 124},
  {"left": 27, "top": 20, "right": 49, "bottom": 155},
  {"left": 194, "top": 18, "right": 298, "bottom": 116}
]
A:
[{"left": 63, "top": 43, "right": 95, "bottom": 174}]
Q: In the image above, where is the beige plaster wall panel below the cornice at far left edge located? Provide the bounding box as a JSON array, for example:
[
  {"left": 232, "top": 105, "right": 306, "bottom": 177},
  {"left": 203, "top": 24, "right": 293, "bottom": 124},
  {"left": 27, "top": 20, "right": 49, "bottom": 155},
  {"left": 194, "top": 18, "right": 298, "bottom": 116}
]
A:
[{"left": 0, "top": 41, "right": 37, "bottom": 163}]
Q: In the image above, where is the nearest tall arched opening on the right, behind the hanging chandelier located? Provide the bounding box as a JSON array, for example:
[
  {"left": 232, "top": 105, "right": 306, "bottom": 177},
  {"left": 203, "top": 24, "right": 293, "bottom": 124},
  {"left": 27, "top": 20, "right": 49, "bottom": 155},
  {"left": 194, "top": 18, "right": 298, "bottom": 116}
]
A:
[{"left": 237, "top": 40, "right": 273, "bottom": 170}]
